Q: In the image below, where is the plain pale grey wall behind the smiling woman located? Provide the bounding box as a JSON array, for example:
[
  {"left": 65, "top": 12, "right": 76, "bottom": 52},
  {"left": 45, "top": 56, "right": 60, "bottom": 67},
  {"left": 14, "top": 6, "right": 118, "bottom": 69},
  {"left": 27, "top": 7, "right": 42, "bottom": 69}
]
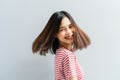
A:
[{"left": 0, "top": 0, "right": 120, "bottom": 80}]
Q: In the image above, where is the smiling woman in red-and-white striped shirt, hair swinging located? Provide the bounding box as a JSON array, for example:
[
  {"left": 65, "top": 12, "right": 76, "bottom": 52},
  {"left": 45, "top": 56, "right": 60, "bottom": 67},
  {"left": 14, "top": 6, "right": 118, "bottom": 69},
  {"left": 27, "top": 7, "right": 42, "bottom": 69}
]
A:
[{"left": 32, "top": 11, "right": 90, "bottom": 80}]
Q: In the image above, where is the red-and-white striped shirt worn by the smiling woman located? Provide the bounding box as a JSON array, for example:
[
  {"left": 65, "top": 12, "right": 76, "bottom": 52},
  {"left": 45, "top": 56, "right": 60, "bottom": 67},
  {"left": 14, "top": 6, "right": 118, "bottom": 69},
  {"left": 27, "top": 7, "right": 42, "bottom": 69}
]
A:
[{"left": 55, "top": 47, "right": 84, "bottom": 80}]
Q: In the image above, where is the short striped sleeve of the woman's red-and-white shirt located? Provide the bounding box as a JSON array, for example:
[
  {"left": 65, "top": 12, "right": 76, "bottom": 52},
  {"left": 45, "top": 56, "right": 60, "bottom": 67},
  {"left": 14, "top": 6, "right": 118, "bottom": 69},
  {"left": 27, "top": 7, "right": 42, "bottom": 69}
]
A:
[{"left": 63, "top": 54, "right": 77, "bottom": 80}]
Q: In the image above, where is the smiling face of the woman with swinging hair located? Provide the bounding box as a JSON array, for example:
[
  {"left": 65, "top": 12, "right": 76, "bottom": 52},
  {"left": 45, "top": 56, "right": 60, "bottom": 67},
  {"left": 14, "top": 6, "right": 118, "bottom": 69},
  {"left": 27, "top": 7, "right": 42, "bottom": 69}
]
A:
[{"left": 57, "top": 17, "right": 75, "bottom": 46}]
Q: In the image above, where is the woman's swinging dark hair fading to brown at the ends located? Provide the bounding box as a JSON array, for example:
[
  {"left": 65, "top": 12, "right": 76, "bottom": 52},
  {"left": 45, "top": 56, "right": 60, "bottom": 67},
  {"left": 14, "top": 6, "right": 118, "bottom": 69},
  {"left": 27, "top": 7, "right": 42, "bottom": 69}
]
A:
[{"left": 32, "top": 11, "right": 90, "bottom": 55}]
